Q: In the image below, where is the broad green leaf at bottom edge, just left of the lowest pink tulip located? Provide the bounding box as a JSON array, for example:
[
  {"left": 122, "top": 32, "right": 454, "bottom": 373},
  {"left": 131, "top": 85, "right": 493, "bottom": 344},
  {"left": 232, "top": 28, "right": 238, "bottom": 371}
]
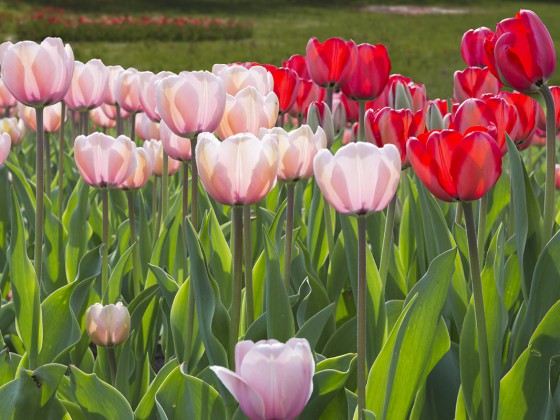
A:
[{"left": 155, "top": 365, "right": 226, "bottom": 420}]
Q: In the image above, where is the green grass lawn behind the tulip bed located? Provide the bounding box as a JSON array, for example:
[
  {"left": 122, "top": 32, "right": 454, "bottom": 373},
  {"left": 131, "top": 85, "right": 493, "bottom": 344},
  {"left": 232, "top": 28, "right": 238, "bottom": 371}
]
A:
[{"left": 0, "top": 0, "right": 560, "bottom": 98}]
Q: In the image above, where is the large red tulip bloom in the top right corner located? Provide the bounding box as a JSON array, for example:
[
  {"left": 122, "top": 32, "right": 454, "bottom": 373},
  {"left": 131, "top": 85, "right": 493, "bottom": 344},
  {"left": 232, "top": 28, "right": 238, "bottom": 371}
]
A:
[{"left": 484, "top": 9, "right": 556, "bottom": 93}]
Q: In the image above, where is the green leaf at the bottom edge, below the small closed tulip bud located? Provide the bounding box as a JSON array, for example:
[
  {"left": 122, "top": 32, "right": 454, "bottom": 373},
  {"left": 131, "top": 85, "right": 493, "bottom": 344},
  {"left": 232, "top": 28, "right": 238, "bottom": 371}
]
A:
[{"left": 70, "top": 366, "right": 134, "bottom": 420}]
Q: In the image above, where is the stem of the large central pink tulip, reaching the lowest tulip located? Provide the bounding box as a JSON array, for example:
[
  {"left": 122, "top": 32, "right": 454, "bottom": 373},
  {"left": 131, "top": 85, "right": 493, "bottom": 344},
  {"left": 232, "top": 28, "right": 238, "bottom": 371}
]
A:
[{"left": 228, "top": 206, "right": 243, "bottom": 367}]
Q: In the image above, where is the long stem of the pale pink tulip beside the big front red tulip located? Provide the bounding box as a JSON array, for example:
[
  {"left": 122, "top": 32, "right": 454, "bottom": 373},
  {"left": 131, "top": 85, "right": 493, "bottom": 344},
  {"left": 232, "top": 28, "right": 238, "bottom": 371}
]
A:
[{"left": 357, "top": 216, "right": 367, "bottom": 419}]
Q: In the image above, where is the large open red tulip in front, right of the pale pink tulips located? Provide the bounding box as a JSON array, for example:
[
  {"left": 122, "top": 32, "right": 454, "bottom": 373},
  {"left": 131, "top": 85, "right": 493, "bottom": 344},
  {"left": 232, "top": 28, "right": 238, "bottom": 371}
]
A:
[{"left": 406, "top": 127, "right": 502, "bottom": 201}]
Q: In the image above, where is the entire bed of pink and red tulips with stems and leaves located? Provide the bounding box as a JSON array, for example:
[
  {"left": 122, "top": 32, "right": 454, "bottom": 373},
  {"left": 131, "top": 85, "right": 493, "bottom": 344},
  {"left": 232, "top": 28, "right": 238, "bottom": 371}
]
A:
[{"left": 0, "top": 5, "right": 560, "bottom": 419}]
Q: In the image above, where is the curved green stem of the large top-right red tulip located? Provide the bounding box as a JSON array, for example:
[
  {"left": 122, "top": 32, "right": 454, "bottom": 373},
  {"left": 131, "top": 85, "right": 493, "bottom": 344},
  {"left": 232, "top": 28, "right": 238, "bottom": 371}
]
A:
[{"left": 540, "top": 85, "right": 556, "bottom": 245}]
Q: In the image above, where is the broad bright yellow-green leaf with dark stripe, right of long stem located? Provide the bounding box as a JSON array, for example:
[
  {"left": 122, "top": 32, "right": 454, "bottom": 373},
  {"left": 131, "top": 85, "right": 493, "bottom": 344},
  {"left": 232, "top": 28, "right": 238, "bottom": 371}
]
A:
[{"left": 366, "top": 249, "right": 456, "bottom": 420}]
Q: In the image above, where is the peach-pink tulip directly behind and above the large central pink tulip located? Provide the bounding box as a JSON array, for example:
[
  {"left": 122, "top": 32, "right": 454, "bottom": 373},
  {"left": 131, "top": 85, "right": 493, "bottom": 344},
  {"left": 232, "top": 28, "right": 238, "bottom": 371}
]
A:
[{"left": 216, "top": 86, "right": 279, "bottom": 139}]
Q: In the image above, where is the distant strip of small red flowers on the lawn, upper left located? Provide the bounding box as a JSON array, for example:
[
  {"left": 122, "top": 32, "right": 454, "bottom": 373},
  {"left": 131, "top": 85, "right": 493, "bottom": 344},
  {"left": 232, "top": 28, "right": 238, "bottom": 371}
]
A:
[{"left": 8, "top": 8, "right": 253, "bottom": 42}]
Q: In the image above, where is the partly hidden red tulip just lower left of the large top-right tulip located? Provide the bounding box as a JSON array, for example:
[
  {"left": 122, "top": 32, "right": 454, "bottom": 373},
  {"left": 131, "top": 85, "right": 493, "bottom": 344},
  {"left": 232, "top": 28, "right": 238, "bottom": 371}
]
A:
[{"left": 453, "top": 67, "right": 500, "bottom": 102}]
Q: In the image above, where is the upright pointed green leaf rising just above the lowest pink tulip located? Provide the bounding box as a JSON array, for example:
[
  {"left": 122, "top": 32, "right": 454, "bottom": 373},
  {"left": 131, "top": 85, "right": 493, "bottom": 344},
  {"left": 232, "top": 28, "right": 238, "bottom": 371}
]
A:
[{"left": 264, "top": 232, "right": 295, "bottom": 342}]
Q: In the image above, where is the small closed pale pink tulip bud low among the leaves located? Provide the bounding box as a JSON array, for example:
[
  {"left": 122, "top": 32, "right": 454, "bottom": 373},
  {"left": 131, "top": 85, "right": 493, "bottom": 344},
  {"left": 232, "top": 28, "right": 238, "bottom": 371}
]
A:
[{"left": 86, "top": 302, "right": 130, "bottom": 347}]
